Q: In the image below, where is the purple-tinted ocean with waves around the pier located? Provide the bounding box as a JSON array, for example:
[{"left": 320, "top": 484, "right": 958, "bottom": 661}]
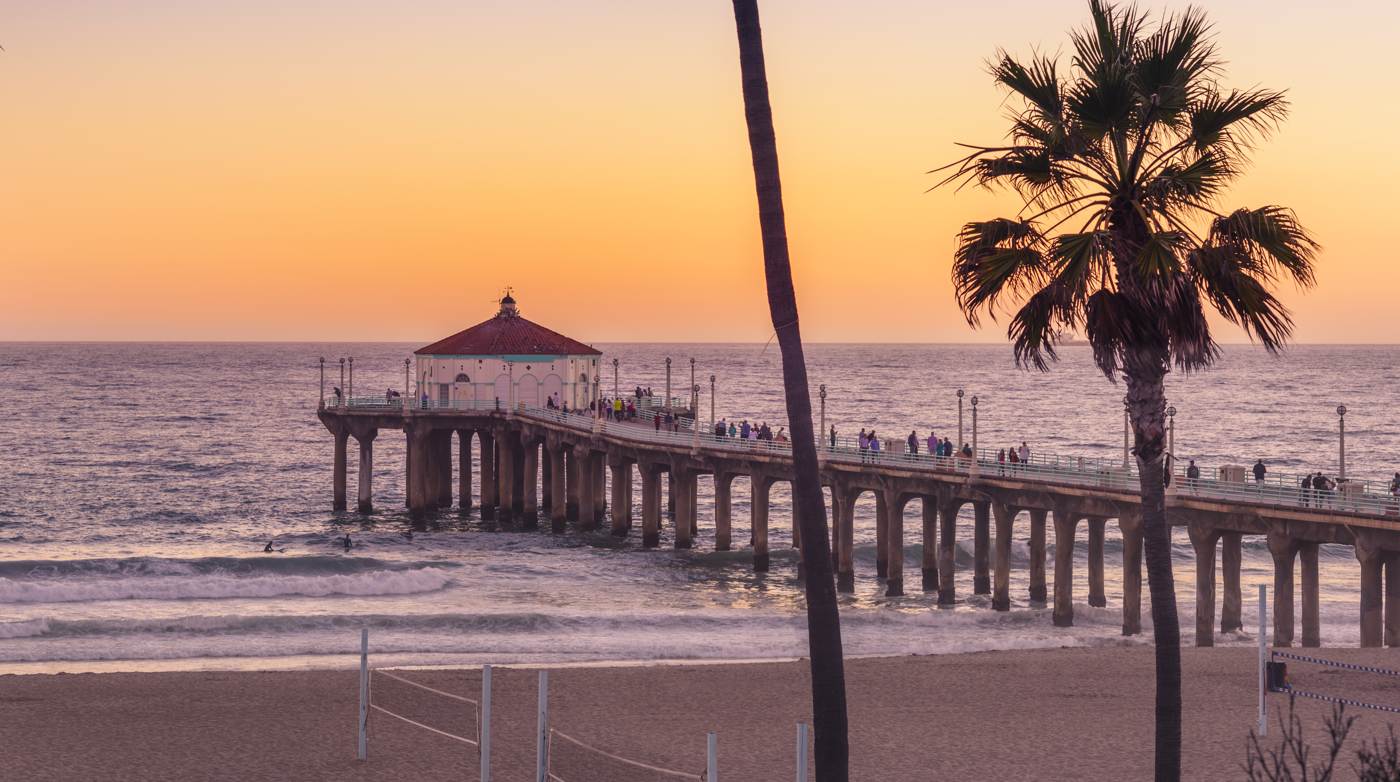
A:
[{"left": 0, "top": 343, "right": 1400, "bottom": 673}]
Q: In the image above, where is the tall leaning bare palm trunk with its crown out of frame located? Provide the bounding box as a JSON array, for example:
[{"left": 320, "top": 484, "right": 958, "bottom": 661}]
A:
[{"left": 734, "top": 0, "right": 848, "bottom": 782}]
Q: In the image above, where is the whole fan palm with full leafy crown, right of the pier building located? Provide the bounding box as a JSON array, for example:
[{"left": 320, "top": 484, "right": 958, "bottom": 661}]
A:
[{"left": 939, "top": 0, "right": 1319, "bottom": 781}]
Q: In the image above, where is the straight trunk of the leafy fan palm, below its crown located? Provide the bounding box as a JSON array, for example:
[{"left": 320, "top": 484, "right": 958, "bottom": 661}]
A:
[{"left": 1124, "top": 351, "right": 1182, "bottom": 782}]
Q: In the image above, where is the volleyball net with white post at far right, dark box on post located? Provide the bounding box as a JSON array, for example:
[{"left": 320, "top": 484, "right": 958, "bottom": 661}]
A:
[{"left": 1259, "top": 585, "right": 1400, "bottom": 736}]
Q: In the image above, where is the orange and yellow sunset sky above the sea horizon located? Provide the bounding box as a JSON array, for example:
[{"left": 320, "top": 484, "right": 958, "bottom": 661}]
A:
[{"left": 0, "top": 0, "right": 1400, "bottom": 343}]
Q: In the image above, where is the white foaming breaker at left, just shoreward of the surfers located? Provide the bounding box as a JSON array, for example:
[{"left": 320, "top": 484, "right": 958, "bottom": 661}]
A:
[{"left": 0, "top": 568, "right": 452, "bottom": 603}]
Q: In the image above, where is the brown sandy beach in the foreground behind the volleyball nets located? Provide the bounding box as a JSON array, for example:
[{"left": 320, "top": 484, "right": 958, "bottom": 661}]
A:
[{"left": 0, "top": 646, "right": 1400, "bottom": 782}]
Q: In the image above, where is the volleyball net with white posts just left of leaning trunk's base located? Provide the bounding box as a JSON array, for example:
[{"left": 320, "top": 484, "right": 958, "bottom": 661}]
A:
[{"left": 535, "top": 670, "right": 720, "bottom": 782}]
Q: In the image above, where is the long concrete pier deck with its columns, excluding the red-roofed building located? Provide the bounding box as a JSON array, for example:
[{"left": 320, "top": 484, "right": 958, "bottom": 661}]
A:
[{"left": 318, "top": 397, "right": 1400, "bottom": 646}]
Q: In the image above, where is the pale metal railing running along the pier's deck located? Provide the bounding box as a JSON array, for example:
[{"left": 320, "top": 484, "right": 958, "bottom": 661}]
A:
[{"left": 330, "top": 396, "right": 1400, "bottom": 516}]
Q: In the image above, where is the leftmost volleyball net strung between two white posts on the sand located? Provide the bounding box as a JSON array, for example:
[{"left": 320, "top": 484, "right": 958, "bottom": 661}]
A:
[{"left": 358, "top": 630, "right": 491, "bottom": 782}]
